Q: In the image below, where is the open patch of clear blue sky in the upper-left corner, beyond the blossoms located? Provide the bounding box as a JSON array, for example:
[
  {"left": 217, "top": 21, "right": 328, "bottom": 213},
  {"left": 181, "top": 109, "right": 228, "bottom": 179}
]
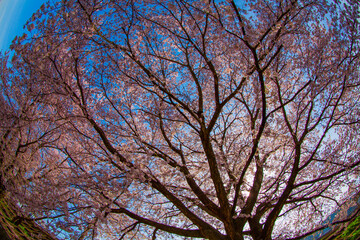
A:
[{"left": 0, "top": 0, "right": 47, "bottom": 51}]
